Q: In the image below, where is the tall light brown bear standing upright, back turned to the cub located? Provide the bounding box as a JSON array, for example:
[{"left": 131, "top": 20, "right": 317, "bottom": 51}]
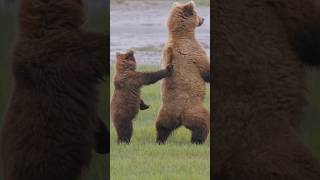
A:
[{"left": 156, "top": 2, "right": 210, "bottom": 143}]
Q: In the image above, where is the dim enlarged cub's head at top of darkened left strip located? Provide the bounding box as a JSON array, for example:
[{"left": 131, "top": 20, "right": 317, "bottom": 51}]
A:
[{"left": 19, "top": 0, "right": 85, "bottom": 36}]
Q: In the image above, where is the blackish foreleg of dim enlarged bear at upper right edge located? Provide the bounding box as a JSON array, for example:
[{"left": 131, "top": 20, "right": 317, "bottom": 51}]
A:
[{"left": 266, "top": 0, "right": 320, "bottom": 67}]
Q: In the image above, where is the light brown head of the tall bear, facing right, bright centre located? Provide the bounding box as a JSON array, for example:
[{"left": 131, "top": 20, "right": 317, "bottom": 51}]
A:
[{"left": 168, "top": 1, "right": 204, "bottom": 33}]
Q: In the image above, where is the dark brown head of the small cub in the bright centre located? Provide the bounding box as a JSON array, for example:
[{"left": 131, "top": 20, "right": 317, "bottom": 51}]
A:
[{"left": 116, "top": 50, "right": 136, "bottom": 72}]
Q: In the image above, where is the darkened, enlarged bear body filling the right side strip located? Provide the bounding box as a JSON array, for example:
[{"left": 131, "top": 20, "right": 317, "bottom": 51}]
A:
[{"left": 211, "top": 0, "right": 320, "bottom": 180}]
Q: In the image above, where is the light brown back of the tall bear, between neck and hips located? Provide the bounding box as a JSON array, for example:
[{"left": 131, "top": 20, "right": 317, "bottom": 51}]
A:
[{"left": 162, "top": 40, "right": 207, "bottom": 101}]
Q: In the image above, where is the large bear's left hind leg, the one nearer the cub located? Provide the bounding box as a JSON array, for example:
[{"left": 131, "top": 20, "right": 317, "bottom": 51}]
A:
[{"left": 156, "top": 108, "right": 180, "bottom": 144}]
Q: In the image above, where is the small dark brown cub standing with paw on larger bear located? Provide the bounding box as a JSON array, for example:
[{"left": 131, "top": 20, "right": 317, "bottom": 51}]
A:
[{"left": 111, "top": 51, "right": 172, "bottom": 143}]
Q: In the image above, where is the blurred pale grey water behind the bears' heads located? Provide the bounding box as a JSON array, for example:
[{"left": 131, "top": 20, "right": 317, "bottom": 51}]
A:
[{"left": 110, "top": 0, "right": 210, "bottom": 65}]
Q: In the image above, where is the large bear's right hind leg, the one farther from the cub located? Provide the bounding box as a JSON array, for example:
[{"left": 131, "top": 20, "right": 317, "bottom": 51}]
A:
[{"left": 182, "top": 105, "right": 210, "bottom": 144}]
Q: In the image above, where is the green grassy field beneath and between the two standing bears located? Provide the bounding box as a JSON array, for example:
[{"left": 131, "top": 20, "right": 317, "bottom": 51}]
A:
[{"left": 110, "top": 66, "right": 210, "bottom": 180}]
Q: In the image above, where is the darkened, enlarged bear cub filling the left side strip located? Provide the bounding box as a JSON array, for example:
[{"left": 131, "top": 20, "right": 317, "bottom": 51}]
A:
[{"left": 0, "top": 0, "right": 109, "bottom": 180}]
